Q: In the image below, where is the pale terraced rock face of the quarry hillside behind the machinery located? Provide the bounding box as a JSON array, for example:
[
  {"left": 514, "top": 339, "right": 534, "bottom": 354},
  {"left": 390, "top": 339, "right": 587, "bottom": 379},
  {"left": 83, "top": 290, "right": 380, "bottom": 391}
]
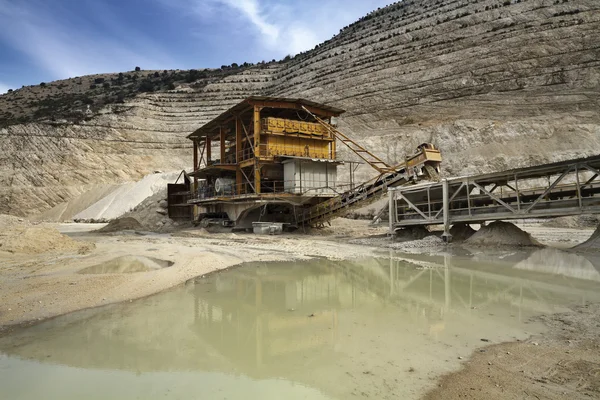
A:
[{"left": 0, "top": 0, "right": 600, "bottom": 215}]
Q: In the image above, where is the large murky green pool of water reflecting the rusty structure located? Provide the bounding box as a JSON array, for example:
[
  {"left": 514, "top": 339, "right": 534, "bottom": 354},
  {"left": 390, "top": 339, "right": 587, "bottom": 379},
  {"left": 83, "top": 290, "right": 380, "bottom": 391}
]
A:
[{"left": 0, "top": 249, "right": 600, "bottom": 400}]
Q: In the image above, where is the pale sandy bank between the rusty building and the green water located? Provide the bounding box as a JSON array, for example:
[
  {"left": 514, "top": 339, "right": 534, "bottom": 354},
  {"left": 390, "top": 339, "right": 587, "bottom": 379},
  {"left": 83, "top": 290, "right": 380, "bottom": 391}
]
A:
[{"left": 0, "top": 220, "right": 384, "bottom": 327}]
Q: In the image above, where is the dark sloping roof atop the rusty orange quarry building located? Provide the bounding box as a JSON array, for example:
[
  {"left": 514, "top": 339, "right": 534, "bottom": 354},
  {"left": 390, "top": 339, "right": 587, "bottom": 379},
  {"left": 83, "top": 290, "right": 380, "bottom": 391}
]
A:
[{"left": 188, "top": 96, "right": 345, "bottom": 139}]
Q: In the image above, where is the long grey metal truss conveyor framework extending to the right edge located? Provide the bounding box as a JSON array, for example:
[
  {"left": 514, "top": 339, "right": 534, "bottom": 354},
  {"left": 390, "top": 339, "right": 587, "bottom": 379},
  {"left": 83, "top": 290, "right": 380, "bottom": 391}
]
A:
[{"left": 389, "top": 155, "right": 600, "bottom": 238}]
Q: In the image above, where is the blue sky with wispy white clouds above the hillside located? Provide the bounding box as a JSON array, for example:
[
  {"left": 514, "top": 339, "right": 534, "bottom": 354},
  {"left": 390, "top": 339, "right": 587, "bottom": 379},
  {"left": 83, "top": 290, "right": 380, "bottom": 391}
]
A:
[{"left": 0, "top": 0, "right": 393, "bottom": 93}]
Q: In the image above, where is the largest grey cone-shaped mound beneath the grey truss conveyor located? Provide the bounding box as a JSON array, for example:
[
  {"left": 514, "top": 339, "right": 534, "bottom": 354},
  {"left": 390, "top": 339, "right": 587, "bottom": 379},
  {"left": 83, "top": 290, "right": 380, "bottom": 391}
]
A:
[{"left": 465, "top": 221, "right": 540, "bottom": 246}]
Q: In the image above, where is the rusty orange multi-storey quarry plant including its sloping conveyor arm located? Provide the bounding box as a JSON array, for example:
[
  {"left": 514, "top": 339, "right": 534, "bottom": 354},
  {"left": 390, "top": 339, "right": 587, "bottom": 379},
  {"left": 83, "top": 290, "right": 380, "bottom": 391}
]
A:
[{"left": 169, "top": 96, "right": 441, "bottom": 229}]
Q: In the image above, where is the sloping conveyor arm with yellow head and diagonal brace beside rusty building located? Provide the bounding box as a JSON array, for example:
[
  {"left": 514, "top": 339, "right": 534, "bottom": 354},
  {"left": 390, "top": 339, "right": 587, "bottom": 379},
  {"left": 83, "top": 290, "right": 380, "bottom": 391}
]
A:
[{"left": 298, "top": 109, "right": 442, "bottom": 226}]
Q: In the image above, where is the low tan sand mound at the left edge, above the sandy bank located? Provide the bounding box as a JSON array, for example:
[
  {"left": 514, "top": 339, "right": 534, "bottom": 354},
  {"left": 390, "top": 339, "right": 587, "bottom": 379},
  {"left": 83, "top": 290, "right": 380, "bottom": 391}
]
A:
[{"left": 0, "top": 215, "right": 95, "bottom": 254}]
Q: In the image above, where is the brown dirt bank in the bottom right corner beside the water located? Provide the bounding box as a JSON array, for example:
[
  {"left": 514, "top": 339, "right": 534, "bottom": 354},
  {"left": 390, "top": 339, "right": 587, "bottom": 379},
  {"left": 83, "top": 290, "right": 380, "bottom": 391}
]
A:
[{"left": 425, "top": 304, "right": 600, "bottom": 400}]
